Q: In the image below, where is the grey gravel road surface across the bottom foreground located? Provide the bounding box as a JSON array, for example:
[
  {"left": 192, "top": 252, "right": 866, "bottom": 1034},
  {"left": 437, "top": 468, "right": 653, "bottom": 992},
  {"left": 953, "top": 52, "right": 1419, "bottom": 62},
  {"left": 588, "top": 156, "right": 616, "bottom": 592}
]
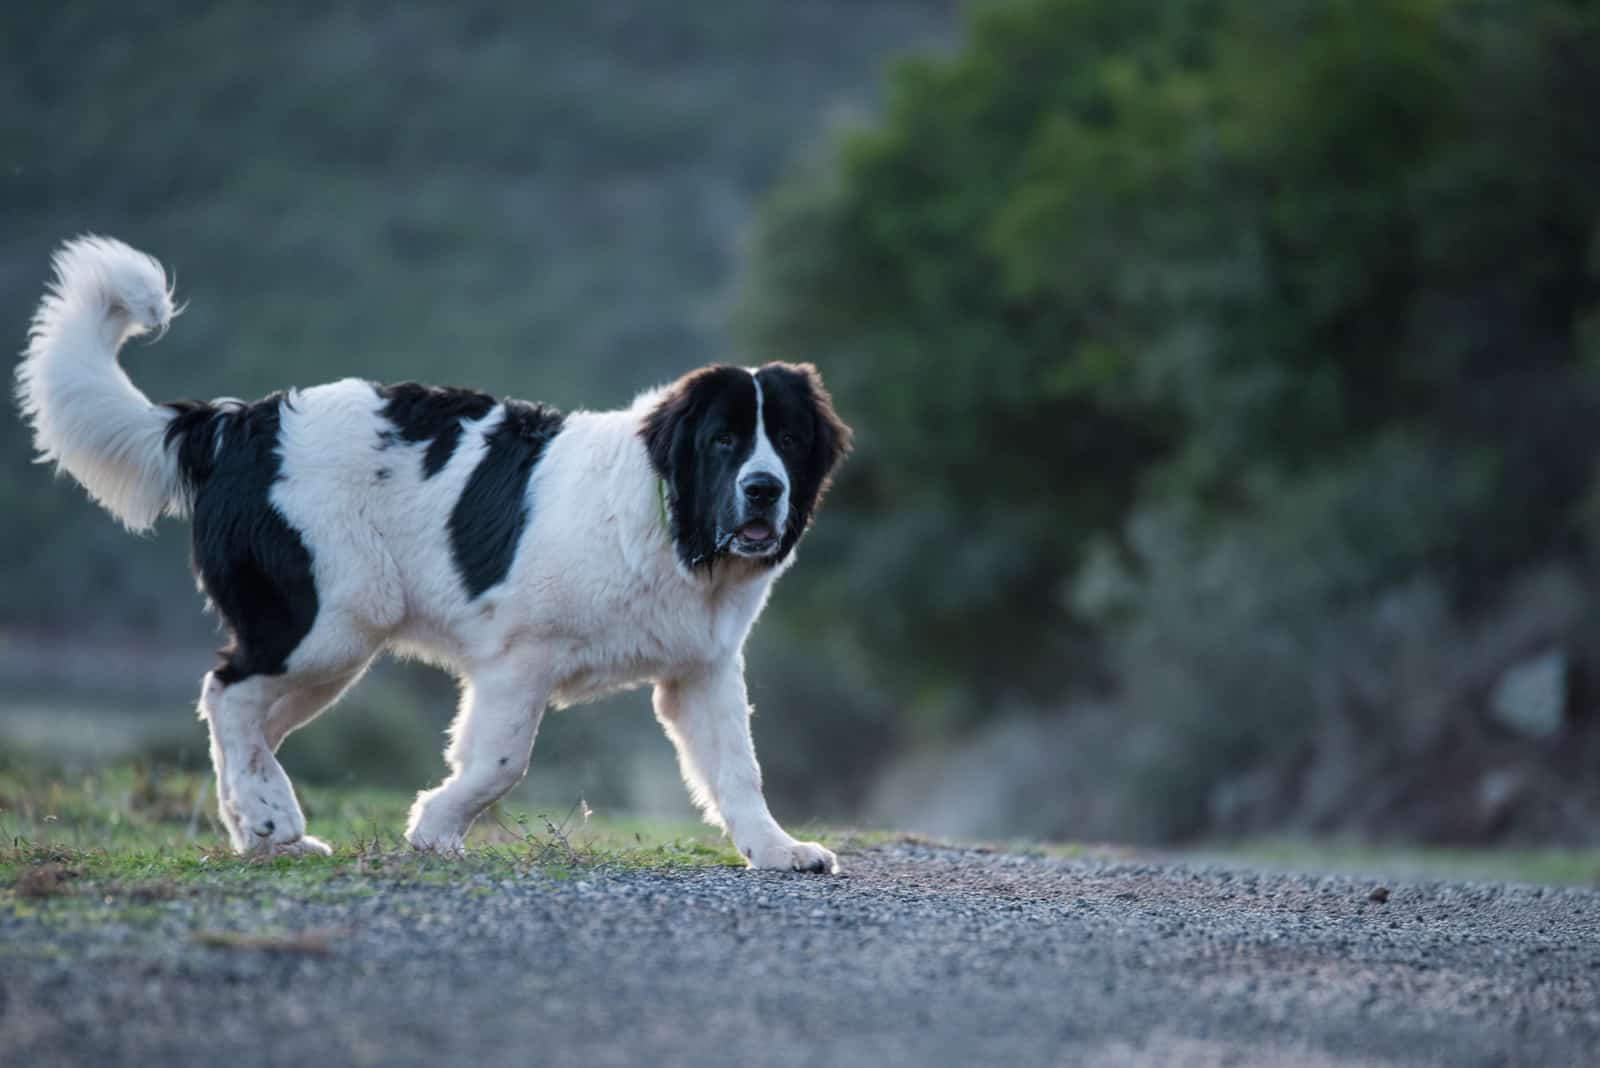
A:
[{"left": 0, "top": 844, "right": 1600, "bottom": 1068}]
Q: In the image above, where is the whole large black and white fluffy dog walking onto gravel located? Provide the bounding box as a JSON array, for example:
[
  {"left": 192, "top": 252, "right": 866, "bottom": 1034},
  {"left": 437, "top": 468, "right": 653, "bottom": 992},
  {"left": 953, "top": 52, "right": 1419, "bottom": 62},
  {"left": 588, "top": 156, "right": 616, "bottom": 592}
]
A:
[{"left": 16, "top": 238, "right": 850, "bottom": 871}]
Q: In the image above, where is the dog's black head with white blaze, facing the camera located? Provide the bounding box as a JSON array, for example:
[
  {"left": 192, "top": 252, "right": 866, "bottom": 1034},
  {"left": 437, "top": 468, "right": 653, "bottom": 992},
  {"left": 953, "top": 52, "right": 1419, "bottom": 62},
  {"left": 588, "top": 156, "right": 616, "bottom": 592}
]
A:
[{"left": 640, "top": 363, "right": 850, "bottom": 569}]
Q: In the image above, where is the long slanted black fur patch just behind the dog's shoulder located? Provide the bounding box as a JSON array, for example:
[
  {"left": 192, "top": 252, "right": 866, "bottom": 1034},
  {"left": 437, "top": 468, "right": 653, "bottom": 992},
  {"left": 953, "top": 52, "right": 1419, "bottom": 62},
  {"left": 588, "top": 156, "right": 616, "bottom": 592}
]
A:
[{"left": 450, "top": 400, "right": 566, "bottom": 596}]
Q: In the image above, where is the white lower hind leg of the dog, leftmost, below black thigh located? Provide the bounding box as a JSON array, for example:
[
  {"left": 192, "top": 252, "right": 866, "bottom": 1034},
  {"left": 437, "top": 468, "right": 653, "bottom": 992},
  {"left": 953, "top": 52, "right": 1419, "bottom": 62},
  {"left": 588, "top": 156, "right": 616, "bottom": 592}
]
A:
[{"left": 200, "top": 671, "right": 330, "bottom": 854}]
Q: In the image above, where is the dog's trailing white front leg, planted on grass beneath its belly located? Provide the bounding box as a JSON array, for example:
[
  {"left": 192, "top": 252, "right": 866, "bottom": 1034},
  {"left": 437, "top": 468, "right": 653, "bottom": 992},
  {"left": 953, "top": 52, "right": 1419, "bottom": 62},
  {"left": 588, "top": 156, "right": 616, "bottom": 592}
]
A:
[{"left": 405, "top": 667, "right": 549, "bottom": 852}]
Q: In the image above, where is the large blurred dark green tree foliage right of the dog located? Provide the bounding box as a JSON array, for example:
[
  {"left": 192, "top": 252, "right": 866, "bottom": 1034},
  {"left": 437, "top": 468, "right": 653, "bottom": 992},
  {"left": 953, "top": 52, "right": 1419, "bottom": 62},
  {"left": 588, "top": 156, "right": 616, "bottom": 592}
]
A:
[{"left": 741, "top": 0, "right": 1600, "bottom": 725}]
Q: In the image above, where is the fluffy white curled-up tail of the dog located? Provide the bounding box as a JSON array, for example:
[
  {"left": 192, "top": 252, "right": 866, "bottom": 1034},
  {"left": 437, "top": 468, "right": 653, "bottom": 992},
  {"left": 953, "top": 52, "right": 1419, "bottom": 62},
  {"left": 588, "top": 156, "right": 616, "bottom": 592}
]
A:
[{"left": 16, "top": 237, "right": 187, "bottom": 531}]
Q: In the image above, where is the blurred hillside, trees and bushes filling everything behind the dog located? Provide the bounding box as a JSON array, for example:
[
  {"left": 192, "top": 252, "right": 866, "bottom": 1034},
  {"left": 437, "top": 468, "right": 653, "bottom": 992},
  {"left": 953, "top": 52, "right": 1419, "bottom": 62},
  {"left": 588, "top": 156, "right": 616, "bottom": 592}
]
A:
[{"left": 9, "top": 0, "right": 1600, "bottom": 846}]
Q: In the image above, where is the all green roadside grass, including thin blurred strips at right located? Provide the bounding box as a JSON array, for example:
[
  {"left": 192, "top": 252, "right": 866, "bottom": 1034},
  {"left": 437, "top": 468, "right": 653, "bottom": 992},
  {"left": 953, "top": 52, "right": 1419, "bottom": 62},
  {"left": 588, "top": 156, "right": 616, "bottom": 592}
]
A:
[{"left": 0, "top": 767, "right": 1600, "bottom": 918}]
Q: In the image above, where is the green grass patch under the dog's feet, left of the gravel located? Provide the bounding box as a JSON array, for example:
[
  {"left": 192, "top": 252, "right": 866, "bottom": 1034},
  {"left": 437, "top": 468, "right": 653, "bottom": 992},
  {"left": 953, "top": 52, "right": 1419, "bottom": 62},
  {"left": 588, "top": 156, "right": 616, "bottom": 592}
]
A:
[{"left": 0, "top": 767, "right": 744, "bottom": 908}]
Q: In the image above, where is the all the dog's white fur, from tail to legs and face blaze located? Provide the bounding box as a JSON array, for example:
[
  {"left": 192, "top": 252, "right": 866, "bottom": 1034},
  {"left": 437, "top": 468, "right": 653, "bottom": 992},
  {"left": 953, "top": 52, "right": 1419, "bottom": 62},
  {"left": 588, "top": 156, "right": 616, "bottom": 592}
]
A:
[{"left": 18, "top": 238, "right": 837, "bottom": 871}]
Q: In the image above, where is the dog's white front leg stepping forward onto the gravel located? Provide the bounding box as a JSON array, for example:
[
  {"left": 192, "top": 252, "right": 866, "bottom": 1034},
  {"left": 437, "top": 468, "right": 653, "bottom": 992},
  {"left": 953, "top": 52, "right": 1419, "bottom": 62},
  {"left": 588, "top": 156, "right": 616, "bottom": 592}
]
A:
[{"left": 654, "top": 657, "right": 838, "bottom": 873}]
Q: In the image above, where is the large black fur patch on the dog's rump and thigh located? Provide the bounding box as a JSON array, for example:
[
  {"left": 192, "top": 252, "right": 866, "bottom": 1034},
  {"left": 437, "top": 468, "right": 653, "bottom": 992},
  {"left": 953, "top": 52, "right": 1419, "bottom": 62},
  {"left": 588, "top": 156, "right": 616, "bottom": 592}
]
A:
[{"left": 166, "top": 393, "right": 317, "bottom": 686}]
